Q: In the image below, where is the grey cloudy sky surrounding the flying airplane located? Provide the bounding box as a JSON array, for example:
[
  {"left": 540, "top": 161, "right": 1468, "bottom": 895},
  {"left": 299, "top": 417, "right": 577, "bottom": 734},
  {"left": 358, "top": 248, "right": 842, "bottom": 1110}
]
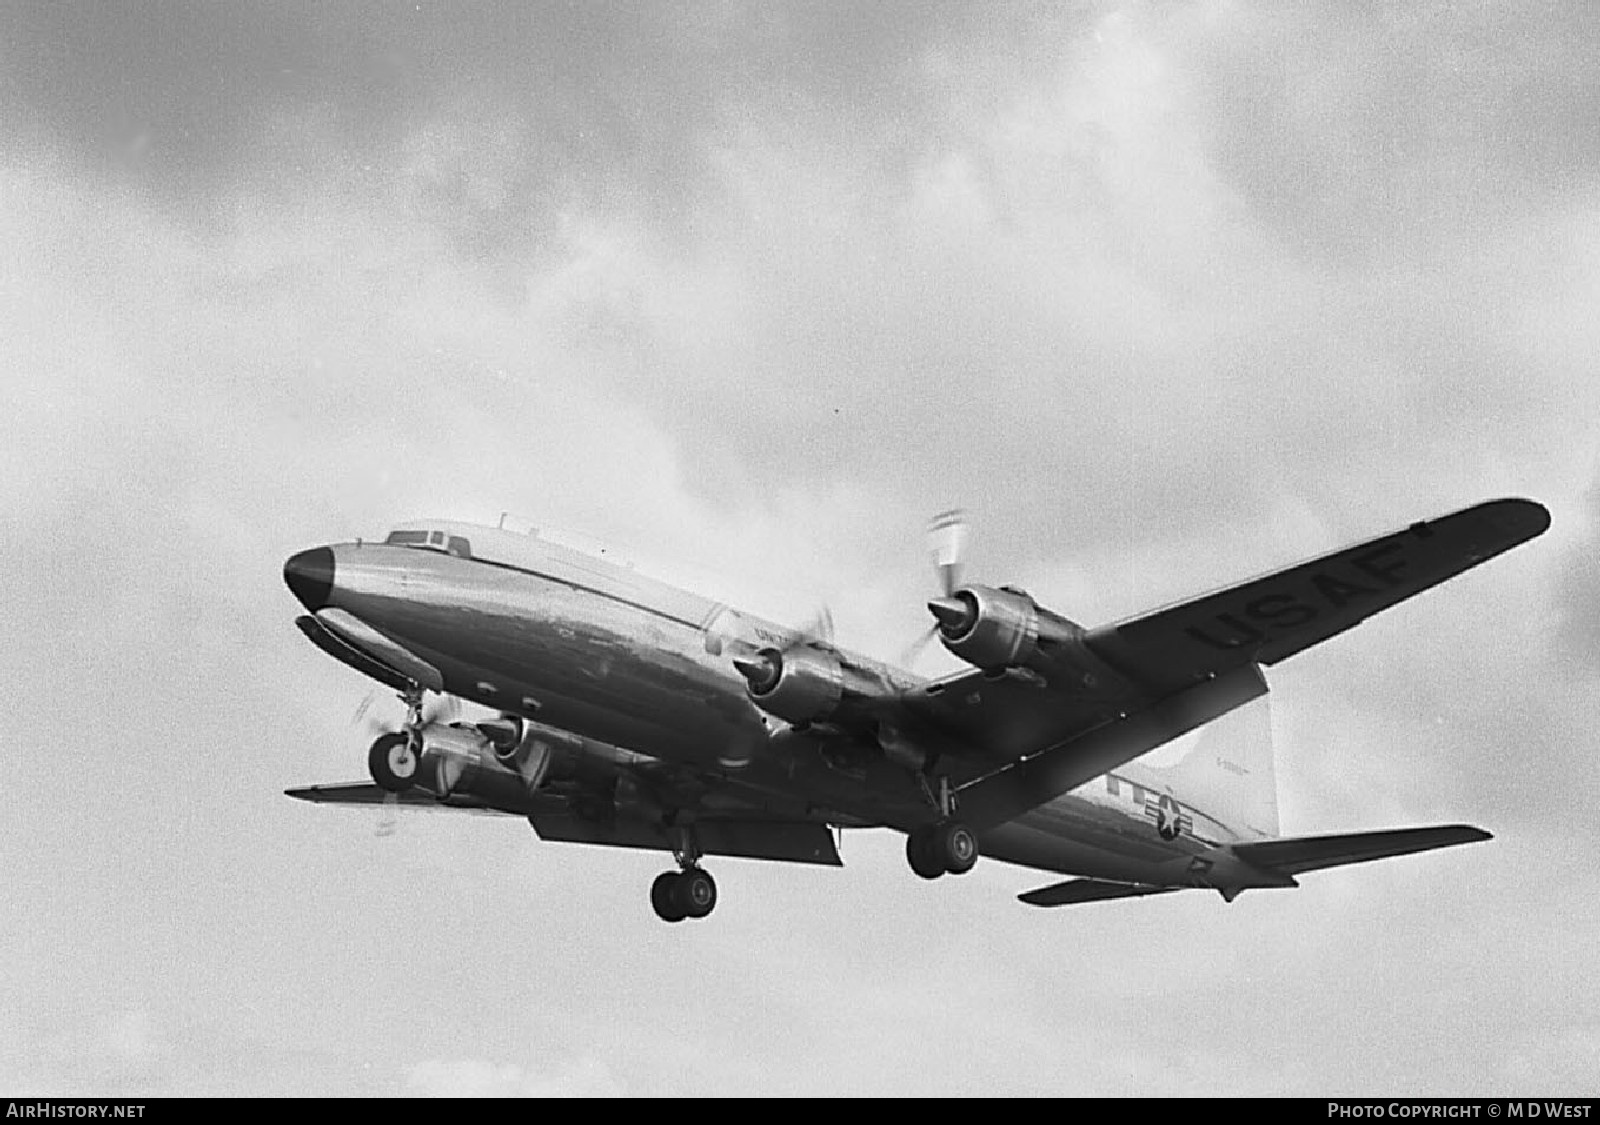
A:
[{"left": 0, "top": 0, "right": 1600, "bottom": 1096}]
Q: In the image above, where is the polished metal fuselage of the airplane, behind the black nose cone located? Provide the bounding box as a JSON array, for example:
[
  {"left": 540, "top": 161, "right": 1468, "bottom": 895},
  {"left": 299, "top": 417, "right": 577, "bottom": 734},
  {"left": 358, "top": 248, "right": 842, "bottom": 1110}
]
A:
[{"left": 308, "top": 525, "right": 1259, "bottom": 885}]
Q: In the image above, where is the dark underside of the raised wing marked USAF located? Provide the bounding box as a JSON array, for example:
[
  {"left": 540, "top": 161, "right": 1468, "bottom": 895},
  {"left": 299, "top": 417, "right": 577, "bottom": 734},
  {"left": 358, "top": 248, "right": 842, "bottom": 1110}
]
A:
[{"left": 901, "top": 499, "right": 1550, "bottom": 826}]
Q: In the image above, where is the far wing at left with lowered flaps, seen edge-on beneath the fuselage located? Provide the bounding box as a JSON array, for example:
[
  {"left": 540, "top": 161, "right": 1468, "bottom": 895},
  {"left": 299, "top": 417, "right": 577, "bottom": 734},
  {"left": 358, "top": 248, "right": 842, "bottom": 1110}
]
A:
[{"left": 285, "top": 783, "right": 843, "bottom": 867}]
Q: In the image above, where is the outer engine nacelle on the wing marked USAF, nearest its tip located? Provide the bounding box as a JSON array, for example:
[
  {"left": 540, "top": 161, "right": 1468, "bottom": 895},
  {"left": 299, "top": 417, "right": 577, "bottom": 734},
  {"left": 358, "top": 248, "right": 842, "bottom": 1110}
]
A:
[{"left": 928, "top": 586, "right": 1118, "bottom": 690}]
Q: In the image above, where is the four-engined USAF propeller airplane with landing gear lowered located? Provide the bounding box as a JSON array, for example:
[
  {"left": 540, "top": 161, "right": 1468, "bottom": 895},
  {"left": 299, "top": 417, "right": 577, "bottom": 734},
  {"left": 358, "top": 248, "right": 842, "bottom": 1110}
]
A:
[{"left": 283, "top": 499, "right": 1550, "bottom": 922}]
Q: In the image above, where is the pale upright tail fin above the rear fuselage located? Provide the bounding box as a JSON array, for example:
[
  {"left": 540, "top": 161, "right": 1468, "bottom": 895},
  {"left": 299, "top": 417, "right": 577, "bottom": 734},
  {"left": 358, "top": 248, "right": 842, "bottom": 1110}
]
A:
[{"left": 1150, "top": 681, "right": 1278, "bottom": 835}]
